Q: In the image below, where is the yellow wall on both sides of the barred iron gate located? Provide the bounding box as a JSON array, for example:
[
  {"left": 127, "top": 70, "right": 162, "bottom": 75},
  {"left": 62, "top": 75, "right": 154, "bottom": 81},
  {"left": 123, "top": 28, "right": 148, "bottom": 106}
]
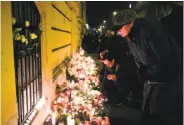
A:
[{"left": 1, "top": 1, "right": 85, "bottom": 125}]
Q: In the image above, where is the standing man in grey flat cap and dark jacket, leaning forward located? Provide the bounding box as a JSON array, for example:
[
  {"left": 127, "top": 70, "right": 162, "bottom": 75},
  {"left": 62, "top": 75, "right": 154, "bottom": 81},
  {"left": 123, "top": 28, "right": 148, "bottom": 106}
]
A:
[{"left": 113, "top": 10, "right": 182, "bottom": 125}]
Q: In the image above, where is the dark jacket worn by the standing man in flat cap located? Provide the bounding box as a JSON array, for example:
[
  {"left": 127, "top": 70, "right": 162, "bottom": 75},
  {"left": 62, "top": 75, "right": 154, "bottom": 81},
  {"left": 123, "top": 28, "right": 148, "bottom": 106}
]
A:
[{"left": 128, "top": 19, "right": 181, "bottom": 81}]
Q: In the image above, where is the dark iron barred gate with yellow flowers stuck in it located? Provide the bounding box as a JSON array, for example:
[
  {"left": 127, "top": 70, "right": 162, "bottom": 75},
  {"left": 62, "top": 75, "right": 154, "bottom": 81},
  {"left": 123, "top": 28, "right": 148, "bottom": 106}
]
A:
[{"left": 12, "top": 1, "right": 42, "bottom": 125}]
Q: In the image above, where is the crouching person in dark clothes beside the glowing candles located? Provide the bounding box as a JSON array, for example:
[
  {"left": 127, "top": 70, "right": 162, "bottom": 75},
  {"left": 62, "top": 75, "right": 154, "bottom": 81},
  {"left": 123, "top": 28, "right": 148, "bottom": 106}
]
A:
[{"left": 100, "top": 50, "right": 141, "bottom": 106}]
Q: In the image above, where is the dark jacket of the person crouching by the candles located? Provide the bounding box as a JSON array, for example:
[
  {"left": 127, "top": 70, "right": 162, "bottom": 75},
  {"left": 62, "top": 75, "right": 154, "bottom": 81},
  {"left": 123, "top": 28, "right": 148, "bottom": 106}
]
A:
[{"left": 101, "top": 60, "right": 138, "bottom": 104}]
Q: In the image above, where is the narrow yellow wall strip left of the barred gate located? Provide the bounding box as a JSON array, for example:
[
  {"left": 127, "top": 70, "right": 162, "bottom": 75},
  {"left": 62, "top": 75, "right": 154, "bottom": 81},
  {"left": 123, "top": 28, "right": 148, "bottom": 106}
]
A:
[{"left": 1, "top": 2, "right": 17, "bottom": 125}]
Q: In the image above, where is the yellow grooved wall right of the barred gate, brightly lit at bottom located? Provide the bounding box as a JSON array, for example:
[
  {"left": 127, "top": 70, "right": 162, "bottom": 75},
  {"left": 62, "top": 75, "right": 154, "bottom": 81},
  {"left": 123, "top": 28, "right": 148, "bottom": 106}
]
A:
[{"left": 36, "top": 1, "right": 80, "bottom": 102}]
